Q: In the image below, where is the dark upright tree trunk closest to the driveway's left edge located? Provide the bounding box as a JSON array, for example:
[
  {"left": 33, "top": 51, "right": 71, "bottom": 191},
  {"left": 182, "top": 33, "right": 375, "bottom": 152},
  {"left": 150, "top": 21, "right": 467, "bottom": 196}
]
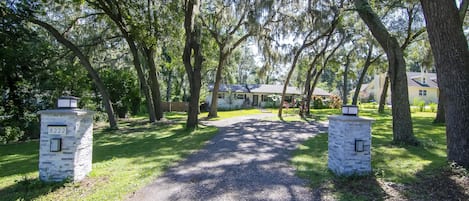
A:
[{"left": 182, "top": 0, "right": 203, "bottom": 129}]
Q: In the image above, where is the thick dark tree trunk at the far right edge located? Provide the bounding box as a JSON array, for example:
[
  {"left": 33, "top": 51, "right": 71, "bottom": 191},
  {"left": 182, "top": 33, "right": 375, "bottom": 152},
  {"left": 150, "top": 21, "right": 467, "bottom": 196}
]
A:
[{"left": 420, "top": 0, "right": 469, "bottom": 168}]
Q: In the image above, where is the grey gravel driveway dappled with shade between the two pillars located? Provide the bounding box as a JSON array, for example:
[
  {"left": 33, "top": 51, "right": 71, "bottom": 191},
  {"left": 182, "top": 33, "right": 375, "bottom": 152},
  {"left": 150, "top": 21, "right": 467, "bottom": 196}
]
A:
[{"left": 129, "top": 113, "right": 325, "bottom": 201}]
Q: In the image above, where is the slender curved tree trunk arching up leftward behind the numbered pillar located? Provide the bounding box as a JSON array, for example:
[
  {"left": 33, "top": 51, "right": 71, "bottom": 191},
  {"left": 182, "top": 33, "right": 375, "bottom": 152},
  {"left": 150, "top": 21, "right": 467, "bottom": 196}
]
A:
[{"left": 29, "top": 18, "right": 118, "bottom": 129}]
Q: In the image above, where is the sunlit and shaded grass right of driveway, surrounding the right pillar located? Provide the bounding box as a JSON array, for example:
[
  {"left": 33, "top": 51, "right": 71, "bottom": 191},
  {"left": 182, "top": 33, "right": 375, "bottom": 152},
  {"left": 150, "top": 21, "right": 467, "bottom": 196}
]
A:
[{"left": 292, "top": 109, "right": 469, "bottom": 200}]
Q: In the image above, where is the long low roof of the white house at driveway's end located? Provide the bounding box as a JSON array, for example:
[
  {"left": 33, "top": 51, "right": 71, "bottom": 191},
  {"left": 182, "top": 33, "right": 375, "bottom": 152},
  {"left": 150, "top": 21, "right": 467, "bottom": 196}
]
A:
[{"left": 208, "top": 84, "right": 331, "bottom": 96}]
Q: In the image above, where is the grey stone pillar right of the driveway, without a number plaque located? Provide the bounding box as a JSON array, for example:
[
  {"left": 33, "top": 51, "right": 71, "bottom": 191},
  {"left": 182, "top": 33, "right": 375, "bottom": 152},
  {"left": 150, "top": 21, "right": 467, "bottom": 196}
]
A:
[{"left": 328, "top": 115, "right": 374, "bottom": 176}]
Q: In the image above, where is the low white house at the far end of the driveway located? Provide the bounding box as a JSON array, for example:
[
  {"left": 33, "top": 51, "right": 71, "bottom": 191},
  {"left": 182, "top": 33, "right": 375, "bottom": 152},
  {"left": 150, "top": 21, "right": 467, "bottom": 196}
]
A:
[{"left": 206, "top": 84, "right": 331, "bottom": 109}]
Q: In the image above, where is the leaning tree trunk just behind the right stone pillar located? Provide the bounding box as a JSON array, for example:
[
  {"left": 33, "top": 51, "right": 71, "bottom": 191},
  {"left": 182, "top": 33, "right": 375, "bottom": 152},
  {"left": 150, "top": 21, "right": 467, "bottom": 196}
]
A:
[{"left": 355, "top": 0, "right": 418, "bottom": 145}]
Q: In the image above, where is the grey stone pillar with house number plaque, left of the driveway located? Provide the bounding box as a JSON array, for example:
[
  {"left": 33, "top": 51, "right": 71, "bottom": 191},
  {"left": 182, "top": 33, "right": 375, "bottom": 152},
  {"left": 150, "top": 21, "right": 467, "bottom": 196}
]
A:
[{"left": 39, "top": 109, "right": 93, "bottom": 181}]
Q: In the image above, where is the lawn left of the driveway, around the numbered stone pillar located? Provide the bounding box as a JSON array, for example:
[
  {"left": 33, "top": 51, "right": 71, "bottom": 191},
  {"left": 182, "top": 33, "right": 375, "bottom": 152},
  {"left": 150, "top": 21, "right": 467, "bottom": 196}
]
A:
[{"left": 0, "top": 118, "right": 217, "bottom": 200}]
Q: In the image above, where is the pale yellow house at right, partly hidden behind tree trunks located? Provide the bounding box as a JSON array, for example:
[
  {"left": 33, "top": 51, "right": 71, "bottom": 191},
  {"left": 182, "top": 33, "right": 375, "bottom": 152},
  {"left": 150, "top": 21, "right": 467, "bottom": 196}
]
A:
[{"left": 360, "top": 70, "right": 439, "bottom": 104}]
